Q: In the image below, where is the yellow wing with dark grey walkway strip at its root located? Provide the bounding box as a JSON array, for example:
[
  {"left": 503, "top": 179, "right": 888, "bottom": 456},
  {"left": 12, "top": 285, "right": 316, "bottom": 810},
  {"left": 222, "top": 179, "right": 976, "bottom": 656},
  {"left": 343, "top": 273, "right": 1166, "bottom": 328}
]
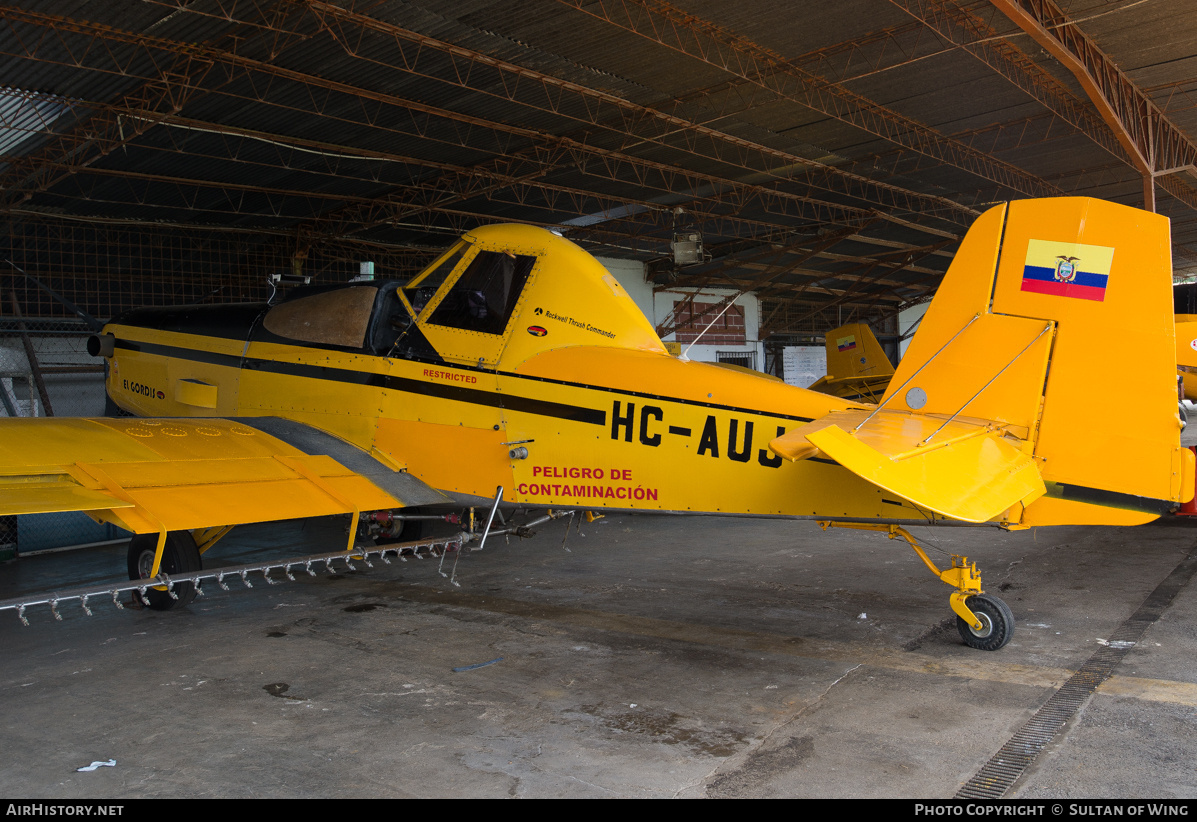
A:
[{"left": 0, "top": 418, "right": 448, "bottom": 534}]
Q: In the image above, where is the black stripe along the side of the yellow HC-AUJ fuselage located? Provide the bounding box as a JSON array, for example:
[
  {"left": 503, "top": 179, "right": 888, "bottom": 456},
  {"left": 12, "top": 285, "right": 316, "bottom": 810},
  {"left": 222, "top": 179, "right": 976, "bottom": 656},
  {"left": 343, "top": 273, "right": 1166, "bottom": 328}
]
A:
[{"left": 116, "top": 339, "right": 810, "bottom": 425}]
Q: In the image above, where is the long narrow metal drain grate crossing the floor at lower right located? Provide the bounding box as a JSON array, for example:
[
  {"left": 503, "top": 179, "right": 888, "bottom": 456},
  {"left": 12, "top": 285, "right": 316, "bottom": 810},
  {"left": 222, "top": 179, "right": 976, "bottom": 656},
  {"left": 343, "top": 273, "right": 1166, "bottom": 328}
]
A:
[{"left": 955, "top": 549, "right": 1197, "bottom": 799}]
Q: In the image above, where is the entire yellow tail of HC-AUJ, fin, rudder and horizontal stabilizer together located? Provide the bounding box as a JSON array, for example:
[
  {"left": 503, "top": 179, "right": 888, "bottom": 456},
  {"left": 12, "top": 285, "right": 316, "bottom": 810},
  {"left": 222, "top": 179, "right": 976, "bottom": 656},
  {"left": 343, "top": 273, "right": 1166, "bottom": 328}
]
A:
[{"left": 770, "top": 197, "right": 1193, "bottom": 526}]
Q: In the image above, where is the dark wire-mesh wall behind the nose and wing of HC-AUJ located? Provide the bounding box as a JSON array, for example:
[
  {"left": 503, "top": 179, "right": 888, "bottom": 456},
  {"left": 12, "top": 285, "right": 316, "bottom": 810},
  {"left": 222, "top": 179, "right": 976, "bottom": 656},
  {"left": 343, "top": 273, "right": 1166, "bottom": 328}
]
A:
[{"left": 0, "top": 214, "right": 439, "bottom": 559}]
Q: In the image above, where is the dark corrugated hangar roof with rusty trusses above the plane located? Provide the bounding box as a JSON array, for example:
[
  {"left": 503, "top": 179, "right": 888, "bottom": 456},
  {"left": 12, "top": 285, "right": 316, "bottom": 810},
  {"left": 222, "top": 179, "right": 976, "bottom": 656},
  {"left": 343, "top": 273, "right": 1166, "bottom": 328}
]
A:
[{"left": 0, "top": 0, "right": 1197, "bottom": 334}]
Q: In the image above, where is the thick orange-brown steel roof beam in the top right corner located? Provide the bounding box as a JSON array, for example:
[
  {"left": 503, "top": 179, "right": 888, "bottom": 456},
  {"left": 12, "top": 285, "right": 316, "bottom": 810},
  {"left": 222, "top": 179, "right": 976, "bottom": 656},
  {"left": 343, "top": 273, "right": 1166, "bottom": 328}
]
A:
[{"left": 990, "top": 0, "right": 1197, "bottom": 211}]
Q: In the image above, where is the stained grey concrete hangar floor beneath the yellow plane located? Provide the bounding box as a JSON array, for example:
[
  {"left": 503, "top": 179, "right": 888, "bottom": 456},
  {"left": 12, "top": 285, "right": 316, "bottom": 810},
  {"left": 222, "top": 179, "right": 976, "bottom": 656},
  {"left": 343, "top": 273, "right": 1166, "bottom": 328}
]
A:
[{"left": 0, "top": 514, "right": 1197, "bottom": 799}]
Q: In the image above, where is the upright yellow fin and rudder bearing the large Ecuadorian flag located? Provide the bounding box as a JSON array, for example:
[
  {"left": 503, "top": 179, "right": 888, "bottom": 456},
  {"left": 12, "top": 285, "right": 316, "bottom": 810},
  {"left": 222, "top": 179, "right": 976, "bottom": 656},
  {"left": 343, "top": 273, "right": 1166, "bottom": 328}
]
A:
[{"left": 885, "top": 197, "right": 1193, "bottom": 525}]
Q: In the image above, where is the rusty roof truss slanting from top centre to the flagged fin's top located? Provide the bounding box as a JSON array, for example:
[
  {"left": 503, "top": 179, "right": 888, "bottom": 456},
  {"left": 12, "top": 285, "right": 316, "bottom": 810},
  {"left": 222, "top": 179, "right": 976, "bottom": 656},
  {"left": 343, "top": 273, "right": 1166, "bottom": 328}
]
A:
[{"left": 560, "top": 0, "right": 1059, "bottom": 197}]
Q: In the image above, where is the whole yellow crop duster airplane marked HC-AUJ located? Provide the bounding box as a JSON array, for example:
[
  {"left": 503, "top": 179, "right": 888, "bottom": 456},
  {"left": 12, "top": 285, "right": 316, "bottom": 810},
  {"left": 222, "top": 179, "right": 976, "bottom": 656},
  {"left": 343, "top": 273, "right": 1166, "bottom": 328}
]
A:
[{"left": 0, "top": 199, "right": 1193, "bottom": 650}]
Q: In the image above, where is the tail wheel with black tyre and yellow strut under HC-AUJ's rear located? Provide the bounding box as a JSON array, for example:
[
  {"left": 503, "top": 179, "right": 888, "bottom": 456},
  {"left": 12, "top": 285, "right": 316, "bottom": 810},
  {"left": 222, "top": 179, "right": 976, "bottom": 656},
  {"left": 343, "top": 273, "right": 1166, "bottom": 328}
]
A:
[{"left": 819, "top": 522, "right": 1014, "bottom": 651}]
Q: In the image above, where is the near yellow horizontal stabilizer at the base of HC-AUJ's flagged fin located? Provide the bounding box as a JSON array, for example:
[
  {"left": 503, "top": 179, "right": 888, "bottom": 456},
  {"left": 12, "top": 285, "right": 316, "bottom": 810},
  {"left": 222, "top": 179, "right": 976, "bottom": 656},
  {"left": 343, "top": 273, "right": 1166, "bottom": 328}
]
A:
[{"left": 770, "top": 410, "right": 1045, "bottom": 523}]
